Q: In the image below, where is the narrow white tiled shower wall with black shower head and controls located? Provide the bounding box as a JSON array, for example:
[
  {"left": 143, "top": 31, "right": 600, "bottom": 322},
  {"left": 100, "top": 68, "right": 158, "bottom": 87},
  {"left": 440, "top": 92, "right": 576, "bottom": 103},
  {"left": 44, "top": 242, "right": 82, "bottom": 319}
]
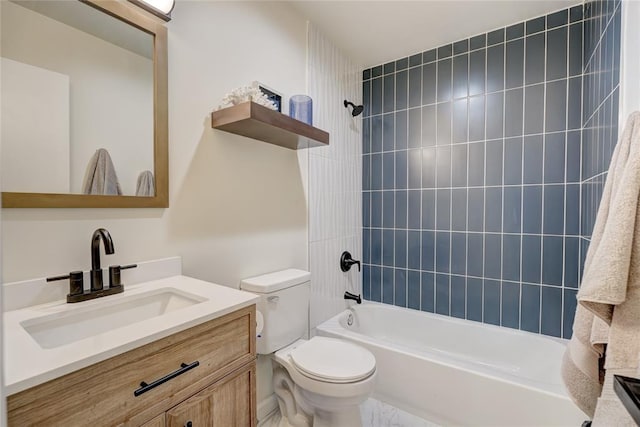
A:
[{"left": 307, "top": 24, "right": 362, "bottom": 330}]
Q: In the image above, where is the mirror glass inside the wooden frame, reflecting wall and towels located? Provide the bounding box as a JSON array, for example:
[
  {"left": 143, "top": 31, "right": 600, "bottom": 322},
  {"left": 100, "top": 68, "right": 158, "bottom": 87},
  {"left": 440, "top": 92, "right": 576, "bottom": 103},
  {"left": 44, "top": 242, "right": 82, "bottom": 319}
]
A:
[{"left": 0, "top": 0, "right": 155, "bottom": 196}]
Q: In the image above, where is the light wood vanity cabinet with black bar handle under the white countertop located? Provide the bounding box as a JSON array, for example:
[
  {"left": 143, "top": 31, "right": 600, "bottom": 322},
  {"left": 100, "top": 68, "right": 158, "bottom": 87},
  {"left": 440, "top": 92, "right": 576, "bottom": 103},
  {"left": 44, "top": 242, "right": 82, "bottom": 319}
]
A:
[{"left": 7, "top": 305, "right": 256, "bottom": 427}]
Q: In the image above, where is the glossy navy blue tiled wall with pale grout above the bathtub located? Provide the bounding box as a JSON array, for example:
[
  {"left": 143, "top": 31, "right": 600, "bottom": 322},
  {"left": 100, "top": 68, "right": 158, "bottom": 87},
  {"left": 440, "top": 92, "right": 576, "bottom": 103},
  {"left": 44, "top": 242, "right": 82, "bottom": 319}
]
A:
[{"left": 362, "top": 0, "right": 620, "bottom": 338}]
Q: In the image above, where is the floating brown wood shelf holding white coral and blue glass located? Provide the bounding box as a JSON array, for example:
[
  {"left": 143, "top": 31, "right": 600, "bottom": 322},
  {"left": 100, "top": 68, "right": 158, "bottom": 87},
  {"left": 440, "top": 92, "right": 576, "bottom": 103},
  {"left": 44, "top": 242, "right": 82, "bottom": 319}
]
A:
[{"left": 211, "top": 102, "right": 329, "bottom": 150}]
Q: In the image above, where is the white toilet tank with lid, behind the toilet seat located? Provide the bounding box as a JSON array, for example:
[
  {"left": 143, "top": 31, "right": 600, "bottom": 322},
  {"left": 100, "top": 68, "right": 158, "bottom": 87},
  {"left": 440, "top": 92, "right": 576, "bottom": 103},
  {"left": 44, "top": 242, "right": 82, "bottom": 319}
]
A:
[{"left": 240, "top": 268, "right": 311, "bottom": 354}]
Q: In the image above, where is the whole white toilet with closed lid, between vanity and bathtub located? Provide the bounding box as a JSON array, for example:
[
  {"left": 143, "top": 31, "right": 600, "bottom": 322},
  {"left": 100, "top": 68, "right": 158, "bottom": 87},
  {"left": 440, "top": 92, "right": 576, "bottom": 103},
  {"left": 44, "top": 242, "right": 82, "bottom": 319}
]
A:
[{"left": 240, "top": 269, "right": 376, "bottom": 427}]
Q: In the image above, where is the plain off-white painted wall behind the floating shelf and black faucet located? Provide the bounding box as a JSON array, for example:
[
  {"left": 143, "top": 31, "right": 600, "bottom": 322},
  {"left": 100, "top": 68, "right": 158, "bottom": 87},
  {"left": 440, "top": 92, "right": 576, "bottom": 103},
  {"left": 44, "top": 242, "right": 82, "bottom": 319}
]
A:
[{"left": 1, "top": 1, "right": 308, "bottom": 422}]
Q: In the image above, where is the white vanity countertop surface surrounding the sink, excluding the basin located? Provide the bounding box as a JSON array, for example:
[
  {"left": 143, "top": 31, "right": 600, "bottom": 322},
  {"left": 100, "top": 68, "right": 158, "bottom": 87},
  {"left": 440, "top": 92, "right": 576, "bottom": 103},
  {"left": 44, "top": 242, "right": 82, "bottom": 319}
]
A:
[{"left": 3, "top": 276, "right": 258, "bottom": 395}]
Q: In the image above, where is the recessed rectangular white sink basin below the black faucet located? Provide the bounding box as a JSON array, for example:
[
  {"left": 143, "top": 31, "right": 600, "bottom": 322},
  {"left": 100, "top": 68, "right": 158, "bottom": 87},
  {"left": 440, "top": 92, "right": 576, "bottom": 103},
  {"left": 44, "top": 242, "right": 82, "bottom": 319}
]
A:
[{"left": 20, "top": 288, "right": 207, "bottom": 349}]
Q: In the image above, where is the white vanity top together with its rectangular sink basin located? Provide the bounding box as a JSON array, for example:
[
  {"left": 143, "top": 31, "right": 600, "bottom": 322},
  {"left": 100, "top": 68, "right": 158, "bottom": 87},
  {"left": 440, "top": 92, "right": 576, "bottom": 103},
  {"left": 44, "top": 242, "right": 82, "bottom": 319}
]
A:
[{"left": 2, "top": 275, "right": 258, "bottom": 396}]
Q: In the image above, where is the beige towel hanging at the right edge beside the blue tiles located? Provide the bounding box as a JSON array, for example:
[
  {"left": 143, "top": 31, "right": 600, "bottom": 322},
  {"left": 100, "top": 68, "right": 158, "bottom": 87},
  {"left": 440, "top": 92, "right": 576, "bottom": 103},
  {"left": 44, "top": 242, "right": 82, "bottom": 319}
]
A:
[{"left": 562, "top": 112, "right": 640, "bottom": 426}]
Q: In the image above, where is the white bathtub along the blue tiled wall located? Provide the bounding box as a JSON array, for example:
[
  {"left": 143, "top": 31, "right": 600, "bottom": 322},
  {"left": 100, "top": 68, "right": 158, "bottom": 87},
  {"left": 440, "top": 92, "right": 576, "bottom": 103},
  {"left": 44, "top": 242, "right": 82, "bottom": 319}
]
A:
[{"left": 317, "top": 302, "right": 587, "bottom": 426}]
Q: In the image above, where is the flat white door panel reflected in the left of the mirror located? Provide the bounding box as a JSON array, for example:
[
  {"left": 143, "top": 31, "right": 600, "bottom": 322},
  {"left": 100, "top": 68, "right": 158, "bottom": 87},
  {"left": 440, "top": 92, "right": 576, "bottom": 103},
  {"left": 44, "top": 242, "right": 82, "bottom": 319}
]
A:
[{"left": 0, "top": 57, "right": 71, "bottom": 193}]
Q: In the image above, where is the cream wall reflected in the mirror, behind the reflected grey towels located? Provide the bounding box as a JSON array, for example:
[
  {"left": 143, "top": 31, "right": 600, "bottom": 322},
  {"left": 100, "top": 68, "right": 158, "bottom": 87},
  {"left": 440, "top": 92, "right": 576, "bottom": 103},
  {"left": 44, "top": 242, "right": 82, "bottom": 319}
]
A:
[{"left": 0, "top": 1, "right": 153, "bottom": 195}]
